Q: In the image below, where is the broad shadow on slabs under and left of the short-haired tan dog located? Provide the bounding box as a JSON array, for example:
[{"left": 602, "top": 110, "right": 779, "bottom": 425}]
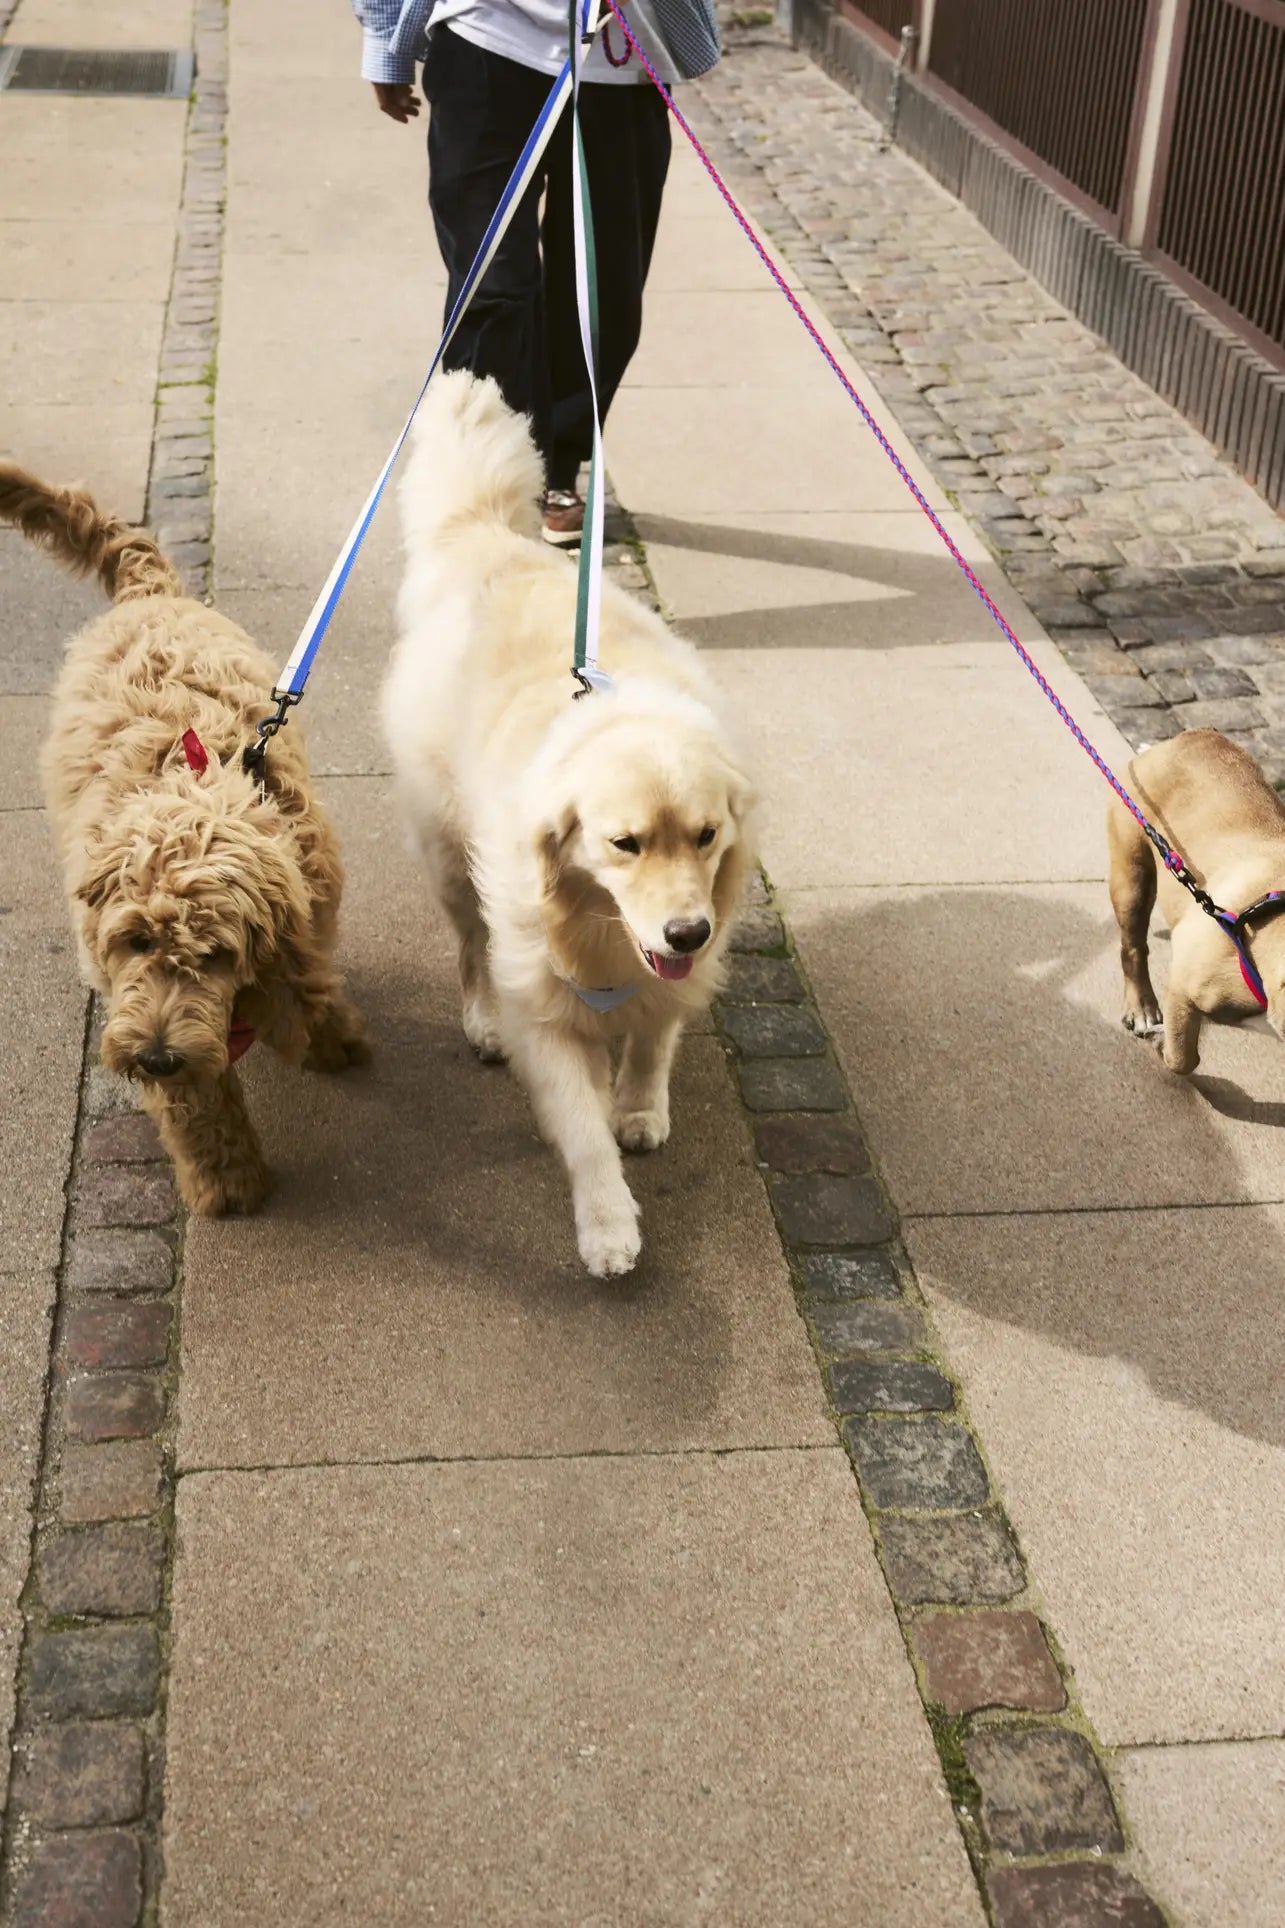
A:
[{"left": 799, "top": 887, "right": 1285, "bottom": 1444}]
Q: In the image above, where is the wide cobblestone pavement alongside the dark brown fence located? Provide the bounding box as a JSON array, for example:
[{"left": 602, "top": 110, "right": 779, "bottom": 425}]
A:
[{"left": 693, "top": 19, "right": 1285, "bottom": 785}]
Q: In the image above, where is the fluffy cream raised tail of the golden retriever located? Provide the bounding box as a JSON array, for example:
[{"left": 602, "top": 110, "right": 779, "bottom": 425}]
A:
[{"left": 401, "top": 370, "right": 544, "bottom": 555}]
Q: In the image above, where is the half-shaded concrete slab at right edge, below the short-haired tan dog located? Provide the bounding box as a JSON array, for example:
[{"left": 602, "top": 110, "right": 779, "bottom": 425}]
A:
[{"left": 907, "top": 1207, "right": 1285, "bottom": 1745}]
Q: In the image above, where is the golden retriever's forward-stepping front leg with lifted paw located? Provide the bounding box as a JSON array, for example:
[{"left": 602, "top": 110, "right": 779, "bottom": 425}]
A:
[{"left": 507, "top": 1022, "right": 643, "bottom": 1278}]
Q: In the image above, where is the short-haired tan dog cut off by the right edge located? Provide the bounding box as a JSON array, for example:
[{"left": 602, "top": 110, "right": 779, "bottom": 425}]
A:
[{"left": 1107, "top": 729, "right": 1285, "bottom": 1072}]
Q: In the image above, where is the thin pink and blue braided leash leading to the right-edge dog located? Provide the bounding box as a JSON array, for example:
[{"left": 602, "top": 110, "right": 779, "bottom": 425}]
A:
[{"left": 606, "top": 0, "right": 1285, "bottom": 1008}]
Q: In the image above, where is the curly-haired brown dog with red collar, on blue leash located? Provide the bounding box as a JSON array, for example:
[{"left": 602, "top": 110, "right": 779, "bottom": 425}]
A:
[{"left": 0, "top": 463, "right": 367, "bottom": 1213}]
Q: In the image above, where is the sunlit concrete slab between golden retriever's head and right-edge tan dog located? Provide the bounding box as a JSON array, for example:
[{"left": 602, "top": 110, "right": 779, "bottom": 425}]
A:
[{"left": 718, "top": 647, "right": 1106, "bottom": 891}]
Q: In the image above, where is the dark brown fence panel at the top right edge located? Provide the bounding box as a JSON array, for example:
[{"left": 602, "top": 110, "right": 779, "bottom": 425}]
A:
[{"left": 1154, "top": 0, "right": 1285, "bottom": 358}]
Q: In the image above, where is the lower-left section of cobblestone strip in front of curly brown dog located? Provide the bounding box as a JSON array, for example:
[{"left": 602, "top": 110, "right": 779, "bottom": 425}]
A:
[{"left": 0, "top": 1026, "right": 179, "bottom": 1928}]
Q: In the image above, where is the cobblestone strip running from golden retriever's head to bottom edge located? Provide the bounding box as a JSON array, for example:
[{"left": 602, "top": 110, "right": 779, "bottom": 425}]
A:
[{"left": 720, "top": 879, "right": 1165, "bottom": 1928}]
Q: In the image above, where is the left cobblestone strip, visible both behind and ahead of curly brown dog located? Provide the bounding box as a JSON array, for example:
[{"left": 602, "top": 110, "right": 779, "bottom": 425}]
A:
[{"left": 0, "top": 0, "right": 226, "bottom": 1928}]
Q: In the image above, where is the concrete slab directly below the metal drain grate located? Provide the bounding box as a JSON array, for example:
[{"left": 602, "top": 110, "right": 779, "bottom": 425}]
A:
[{"left": 0, "top": 93, "right": 187, "bottom": 224}]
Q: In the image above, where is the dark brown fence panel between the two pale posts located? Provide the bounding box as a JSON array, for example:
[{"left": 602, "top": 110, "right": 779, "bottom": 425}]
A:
[{"left": 928, "top": 0, "right": 1150, "bottom": 216}]
